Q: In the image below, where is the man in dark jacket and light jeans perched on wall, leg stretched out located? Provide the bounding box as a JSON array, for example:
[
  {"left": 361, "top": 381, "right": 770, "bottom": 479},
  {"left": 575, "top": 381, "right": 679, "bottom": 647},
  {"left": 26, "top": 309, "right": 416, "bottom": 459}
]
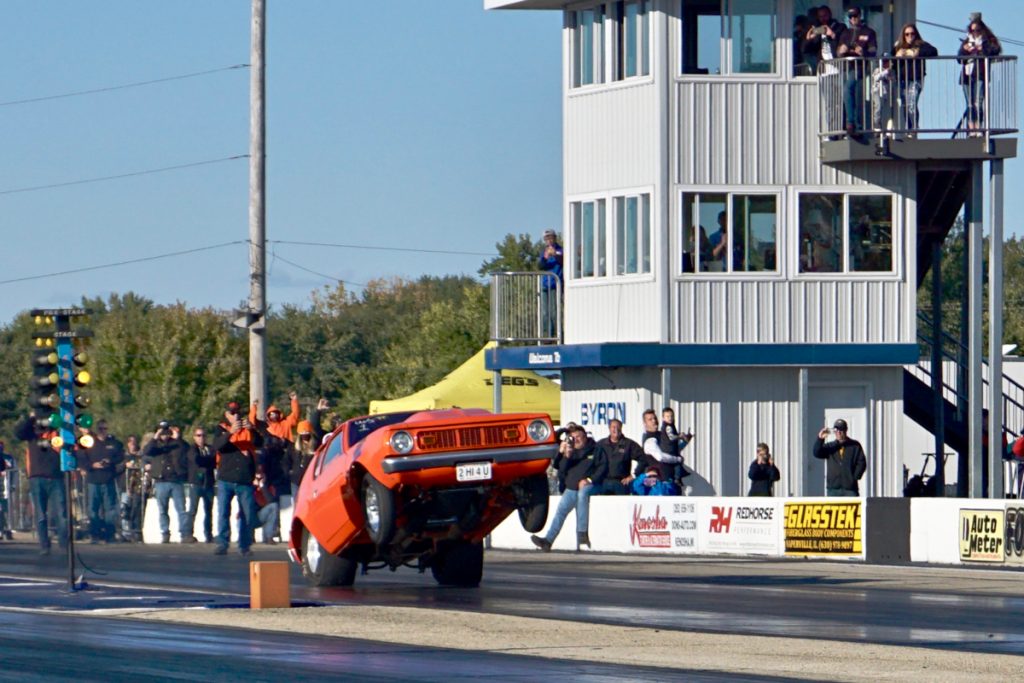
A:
[{"left": 529, "top": 425, "right": 604, "bottom": 552}]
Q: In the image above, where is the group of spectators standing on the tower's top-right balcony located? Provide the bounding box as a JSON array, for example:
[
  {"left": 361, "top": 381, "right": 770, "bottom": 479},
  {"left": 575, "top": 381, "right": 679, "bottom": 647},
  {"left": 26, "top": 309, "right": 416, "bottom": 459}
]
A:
[{"left": 793, "top": 5, "right": 1002, "bottom": 137}]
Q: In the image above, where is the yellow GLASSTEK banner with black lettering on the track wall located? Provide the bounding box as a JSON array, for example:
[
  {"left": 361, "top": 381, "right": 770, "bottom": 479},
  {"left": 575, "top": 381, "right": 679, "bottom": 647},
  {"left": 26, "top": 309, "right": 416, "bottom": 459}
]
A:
[{"left": 784, "top": 499, "right": 864, "bottom": 556}]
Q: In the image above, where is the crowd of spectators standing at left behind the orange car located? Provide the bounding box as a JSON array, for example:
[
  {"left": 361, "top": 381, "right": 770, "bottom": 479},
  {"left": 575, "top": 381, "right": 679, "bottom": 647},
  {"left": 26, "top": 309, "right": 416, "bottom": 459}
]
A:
[{"left": 7, "top": 392, "right": 328, "bottom": 555}]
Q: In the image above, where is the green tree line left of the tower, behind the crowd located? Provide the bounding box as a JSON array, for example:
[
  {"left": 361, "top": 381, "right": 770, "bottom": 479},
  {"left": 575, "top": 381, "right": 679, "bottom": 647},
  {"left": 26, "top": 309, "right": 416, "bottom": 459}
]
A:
[{"left": 0, "top": 234, "right": 541, "bottom": 454}]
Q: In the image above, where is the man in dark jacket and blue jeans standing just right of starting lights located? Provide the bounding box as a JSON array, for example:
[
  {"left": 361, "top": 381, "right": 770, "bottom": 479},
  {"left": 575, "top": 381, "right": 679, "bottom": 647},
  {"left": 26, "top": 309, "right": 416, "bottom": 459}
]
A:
[{"left": 78, "top": 420, "right": 125, "bottom": 543}]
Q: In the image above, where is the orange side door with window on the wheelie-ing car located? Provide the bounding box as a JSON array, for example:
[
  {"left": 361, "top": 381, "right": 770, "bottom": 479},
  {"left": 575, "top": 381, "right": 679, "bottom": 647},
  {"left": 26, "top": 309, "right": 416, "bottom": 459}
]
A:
[{"left": 302, "top": 429, "right": 351, "bottom": 552}]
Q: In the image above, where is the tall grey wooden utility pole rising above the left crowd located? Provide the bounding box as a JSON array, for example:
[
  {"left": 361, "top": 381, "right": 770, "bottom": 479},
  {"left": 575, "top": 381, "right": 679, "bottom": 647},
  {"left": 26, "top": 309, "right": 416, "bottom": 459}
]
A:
[{"left": 248, "top": 0, "right": 266, "bottom": 419}]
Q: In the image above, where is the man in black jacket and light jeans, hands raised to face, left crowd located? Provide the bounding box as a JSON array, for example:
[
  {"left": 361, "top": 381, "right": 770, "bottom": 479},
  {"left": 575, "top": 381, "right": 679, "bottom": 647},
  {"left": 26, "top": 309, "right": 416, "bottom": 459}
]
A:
[{"left": 142, "top": 421, "right": 196, "bottom": 543}]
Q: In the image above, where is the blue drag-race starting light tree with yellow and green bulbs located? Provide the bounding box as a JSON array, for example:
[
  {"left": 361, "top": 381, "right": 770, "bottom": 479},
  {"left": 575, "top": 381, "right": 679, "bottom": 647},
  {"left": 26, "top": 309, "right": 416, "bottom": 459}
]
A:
[{"left": 31, "top": 308, "right": 93, "bottom": 472}]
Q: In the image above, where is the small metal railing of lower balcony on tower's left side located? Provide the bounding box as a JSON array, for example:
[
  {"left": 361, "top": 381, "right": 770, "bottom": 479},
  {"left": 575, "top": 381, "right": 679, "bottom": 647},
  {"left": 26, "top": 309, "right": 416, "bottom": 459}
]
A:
[{"left": 490, "top": 271, "right": 562, "bottom": 344}]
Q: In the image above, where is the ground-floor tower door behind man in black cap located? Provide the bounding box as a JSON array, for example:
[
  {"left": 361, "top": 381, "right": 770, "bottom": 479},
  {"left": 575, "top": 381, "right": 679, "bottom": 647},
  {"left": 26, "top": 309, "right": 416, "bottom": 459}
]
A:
[{"left": 803, "top": 384, "right": 870, "bottom": 496}]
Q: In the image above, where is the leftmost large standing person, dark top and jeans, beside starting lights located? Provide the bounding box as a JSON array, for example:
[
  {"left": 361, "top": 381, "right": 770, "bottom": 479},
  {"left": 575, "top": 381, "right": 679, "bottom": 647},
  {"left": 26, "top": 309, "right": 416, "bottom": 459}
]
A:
[{"left": 14, "top": 412, "right": 68, "bottom": 555}]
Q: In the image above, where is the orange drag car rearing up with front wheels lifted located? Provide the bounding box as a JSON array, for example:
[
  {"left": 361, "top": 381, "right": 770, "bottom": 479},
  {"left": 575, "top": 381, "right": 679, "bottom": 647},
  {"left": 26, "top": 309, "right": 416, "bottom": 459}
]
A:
[{"left": 289, "top": 409, "right": 557, "bottom": 586}]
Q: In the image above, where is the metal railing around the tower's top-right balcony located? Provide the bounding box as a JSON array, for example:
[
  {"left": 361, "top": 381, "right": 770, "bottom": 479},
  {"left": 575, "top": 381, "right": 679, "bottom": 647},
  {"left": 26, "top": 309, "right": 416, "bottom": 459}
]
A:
[{"left": 817, "top": 56, "right": 1017, "bottom": 139}]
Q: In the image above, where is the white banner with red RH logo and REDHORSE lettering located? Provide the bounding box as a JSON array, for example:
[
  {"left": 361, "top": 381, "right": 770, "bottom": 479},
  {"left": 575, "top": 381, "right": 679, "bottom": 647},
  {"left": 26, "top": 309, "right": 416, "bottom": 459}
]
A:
[{"left": 699, "top": 498, "right": 782, "bottom": 555}]
